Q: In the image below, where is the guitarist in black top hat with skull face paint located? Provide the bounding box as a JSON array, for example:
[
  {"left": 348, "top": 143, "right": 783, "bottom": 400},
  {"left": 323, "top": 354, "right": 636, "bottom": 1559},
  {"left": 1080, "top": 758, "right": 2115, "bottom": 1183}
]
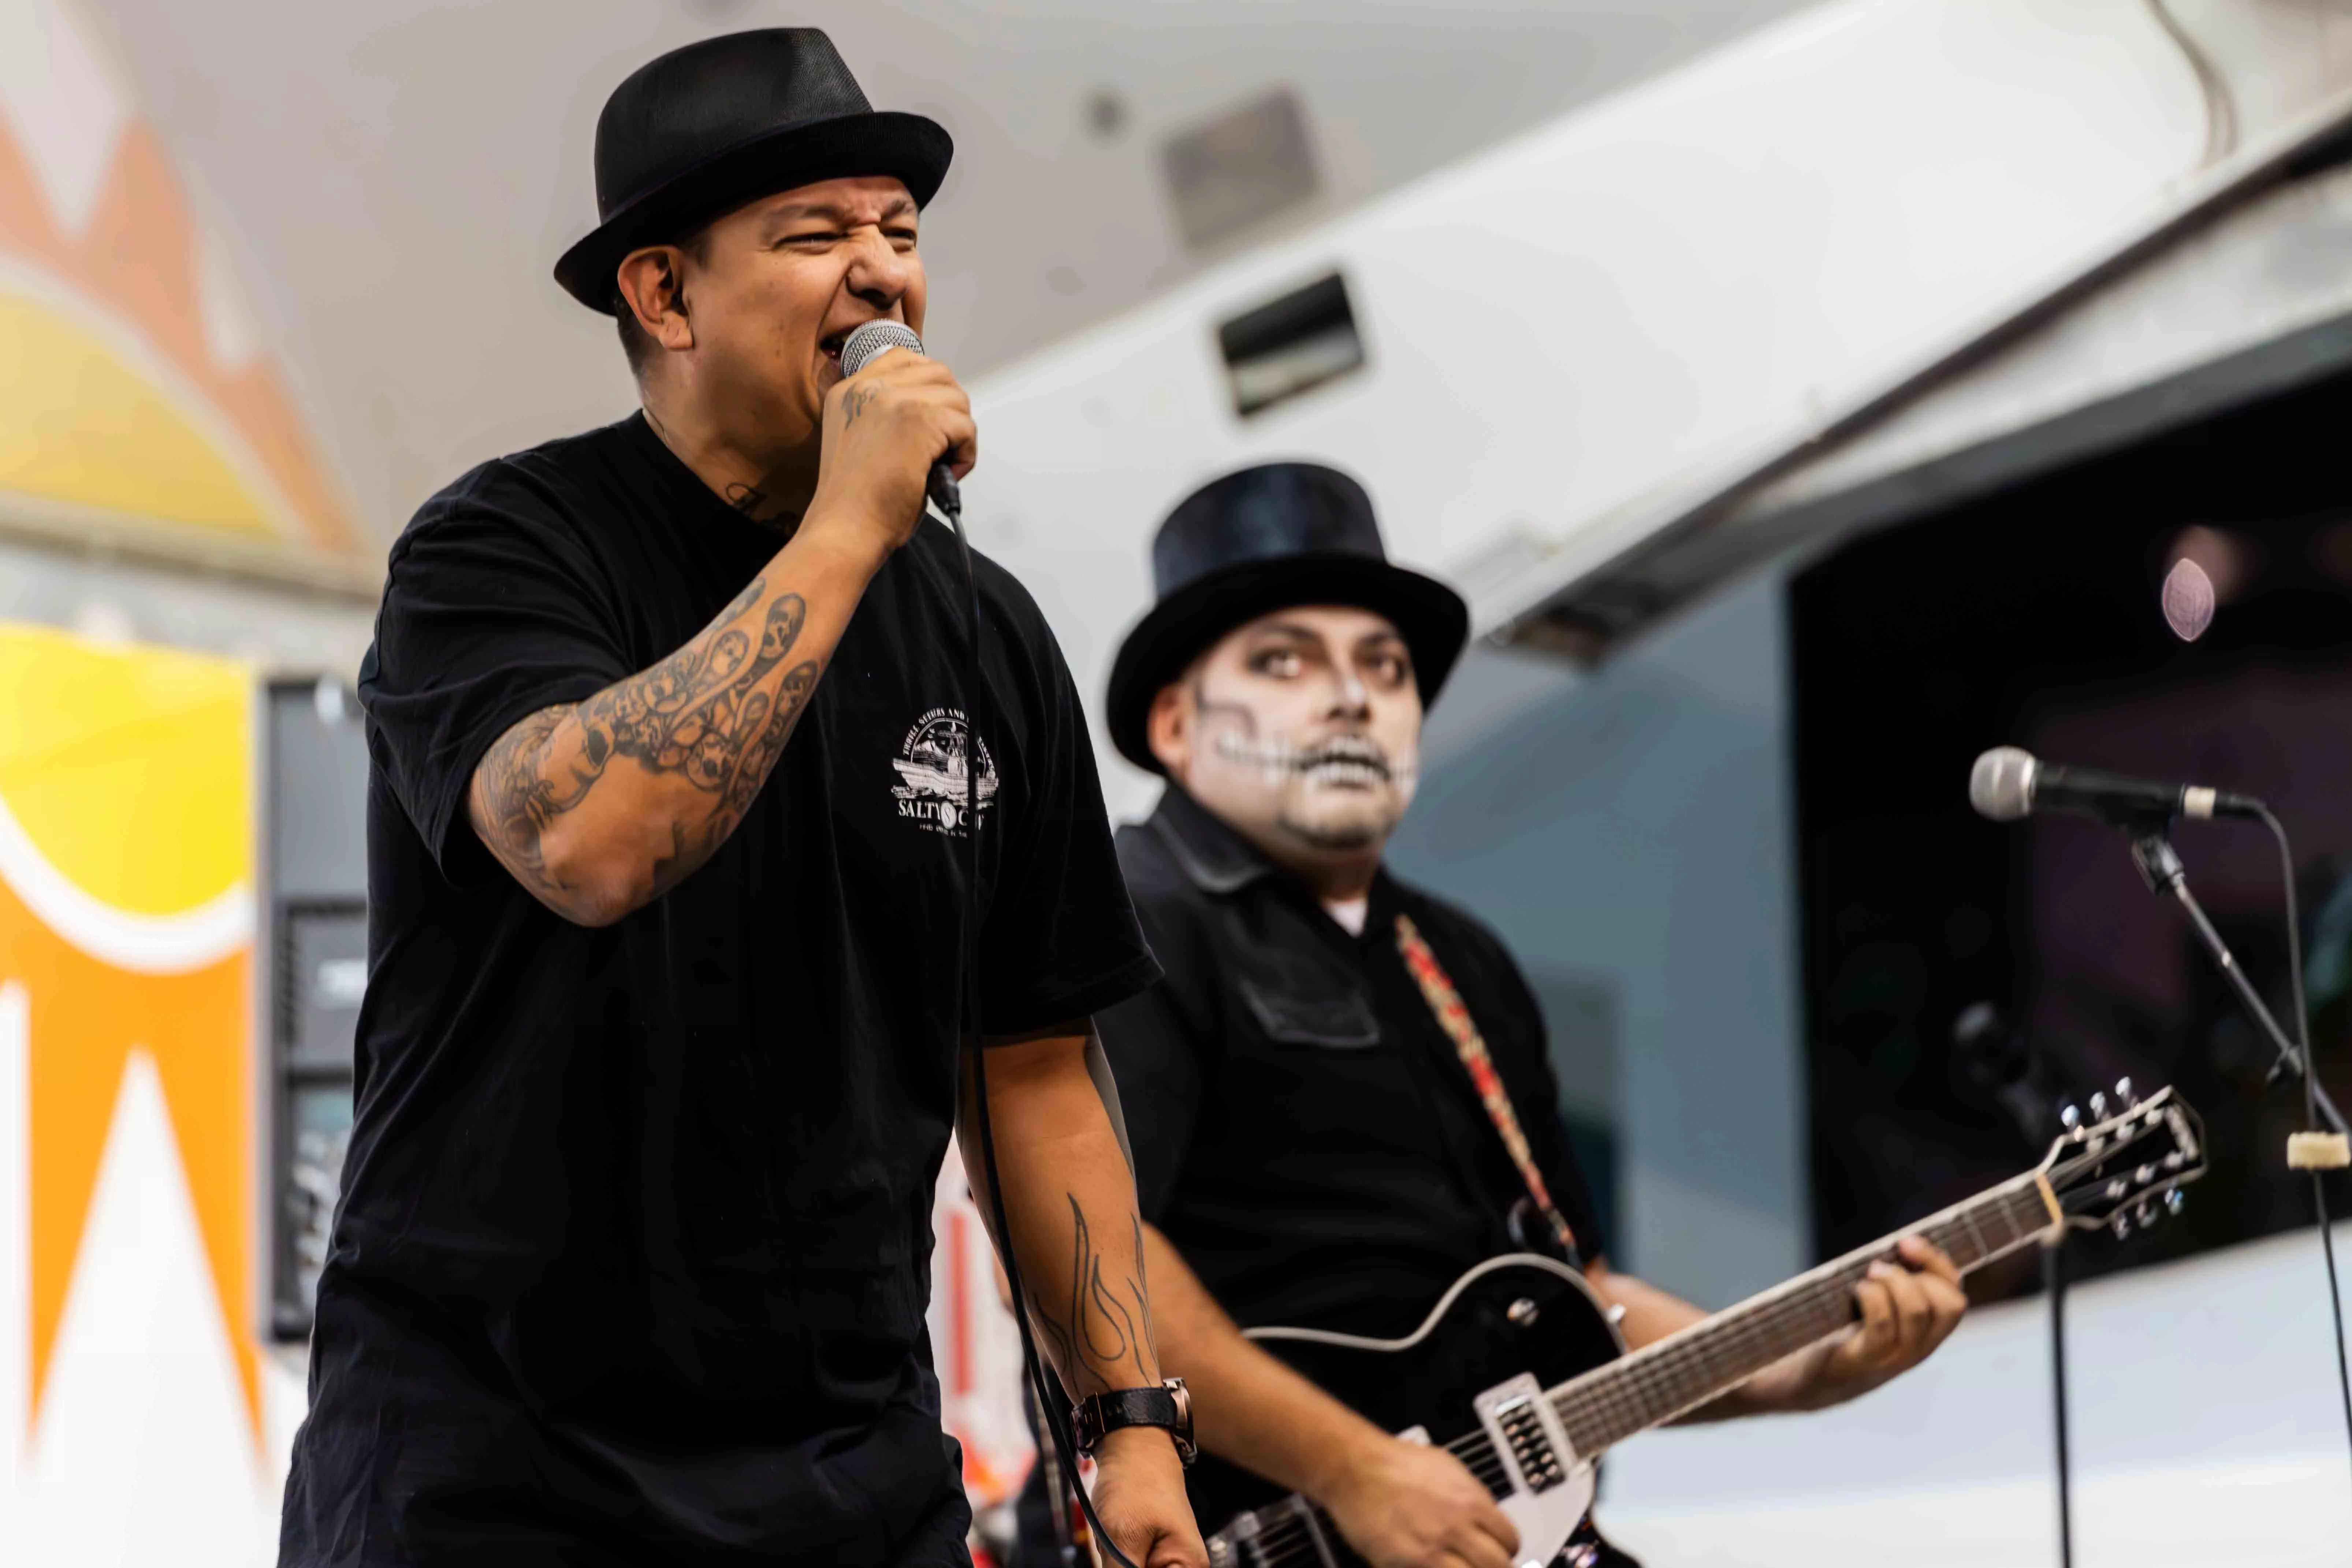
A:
[{"left": 1049, "top": 463, "right": 1966, "bottom": 1568}]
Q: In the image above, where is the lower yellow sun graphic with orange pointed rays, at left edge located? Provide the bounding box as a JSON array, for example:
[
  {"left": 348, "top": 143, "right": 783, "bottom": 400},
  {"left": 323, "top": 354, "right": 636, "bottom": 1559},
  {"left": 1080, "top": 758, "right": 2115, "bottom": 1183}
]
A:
[{"left": 0, "top": 627, "right": 261, "bottom": 1439}]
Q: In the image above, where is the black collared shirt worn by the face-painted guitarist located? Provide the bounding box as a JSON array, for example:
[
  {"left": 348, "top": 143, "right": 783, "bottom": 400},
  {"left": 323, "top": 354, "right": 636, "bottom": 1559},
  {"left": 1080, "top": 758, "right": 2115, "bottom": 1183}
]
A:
[{"left": 1096, "top": 785, "right": 1602, "bottom": 1335}]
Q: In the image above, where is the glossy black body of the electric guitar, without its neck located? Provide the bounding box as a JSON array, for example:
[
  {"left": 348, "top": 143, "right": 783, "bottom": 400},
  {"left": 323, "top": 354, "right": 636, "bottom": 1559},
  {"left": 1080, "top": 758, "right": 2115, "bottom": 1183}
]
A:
[{"left": 1186, "top": 1253, "right": 1625, "bottom": 1568}]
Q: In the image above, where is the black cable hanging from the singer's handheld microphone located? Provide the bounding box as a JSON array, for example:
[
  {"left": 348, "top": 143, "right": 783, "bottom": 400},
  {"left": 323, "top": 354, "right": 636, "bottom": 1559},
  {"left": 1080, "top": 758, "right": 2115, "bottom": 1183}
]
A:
[{"left": 931, "top": 479, "right": 1138, "bottom": 1568}]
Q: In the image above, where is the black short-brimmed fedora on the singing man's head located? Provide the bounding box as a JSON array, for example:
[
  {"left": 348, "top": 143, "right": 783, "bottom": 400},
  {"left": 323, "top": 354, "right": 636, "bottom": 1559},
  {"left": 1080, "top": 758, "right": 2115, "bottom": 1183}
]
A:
[{"left": 555, "top": 28, "right": 955, "bottom": 315}]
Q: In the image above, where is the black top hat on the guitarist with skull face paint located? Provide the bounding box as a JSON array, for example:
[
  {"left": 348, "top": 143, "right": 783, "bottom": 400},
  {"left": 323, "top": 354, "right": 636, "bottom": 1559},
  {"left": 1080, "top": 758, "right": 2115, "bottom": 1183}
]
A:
[{"left": 1105, "top": 463, "right": 1470, "bottom": 774}]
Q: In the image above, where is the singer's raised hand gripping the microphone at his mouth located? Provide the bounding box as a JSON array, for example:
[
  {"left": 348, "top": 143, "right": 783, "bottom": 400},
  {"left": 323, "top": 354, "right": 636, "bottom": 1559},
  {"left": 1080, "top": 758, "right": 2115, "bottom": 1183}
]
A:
[{"left": 802, "top": 350, "right": 981, "bottom": 562}]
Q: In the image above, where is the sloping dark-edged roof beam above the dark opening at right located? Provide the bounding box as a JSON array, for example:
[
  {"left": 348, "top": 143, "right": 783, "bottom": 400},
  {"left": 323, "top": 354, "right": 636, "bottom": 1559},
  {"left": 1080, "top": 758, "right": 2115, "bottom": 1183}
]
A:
[{"left": 1493, "top": 89, "right": 2352, "bottom": 663}]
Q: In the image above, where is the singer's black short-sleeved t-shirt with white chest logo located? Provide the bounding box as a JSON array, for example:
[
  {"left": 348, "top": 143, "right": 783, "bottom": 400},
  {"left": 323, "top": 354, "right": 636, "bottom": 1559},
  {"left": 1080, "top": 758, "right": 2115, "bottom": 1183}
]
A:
[{"left": 280, "top": 416, "right": 1157, "bottom": 1568}]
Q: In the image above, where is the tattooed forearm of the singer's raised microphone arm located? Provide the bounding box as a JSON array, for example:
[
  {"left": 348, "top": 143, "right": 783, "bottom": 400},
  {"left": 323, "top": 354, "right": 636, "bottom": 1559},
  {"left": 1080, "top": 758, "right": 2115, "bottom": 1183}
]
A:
[{"left": 470, "top": 578, "right": 821, "bottom": 912}]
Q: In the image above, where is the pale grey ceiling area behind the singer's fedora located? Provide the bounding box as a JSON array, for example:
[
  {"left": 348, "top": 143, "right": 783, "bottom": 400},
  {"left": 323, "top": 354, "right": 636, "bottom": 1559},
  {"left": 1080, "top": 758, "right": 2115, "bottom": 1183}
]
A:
[{"left": 64, "top": 0, "right": 1802, "bottom": 536}]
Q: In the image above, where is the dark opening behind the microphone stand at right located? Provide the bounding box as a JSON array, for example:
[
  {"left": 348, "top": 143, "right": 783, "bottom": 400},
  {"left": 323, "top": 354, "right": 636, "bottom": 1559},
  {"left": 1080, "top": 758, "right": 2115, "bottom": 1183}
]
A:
[{"left": 1790, "top": 364, "right": 2352, "bottom": 1293}]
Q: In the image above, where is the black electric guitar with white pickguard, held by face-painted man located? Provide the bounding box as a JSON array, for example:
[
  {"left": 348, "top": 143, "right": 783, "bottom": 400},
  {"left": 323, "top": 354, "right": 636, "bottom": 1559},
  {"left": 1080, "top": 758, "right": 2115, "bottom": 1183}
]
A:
[{"left": 1188, "top": 1086, "right": 2206, "bottom": 1568}]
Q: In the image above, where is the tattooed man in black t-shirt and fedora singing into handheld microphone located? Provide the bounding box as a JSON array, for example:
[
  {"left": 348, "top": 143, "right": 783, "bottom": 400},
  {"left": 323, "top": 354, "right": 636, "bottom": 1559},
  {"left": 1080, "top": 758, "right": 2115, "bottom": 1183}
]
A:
[{"left": 280, "top": 30, "right": 1204, "bottom": 1568}]
